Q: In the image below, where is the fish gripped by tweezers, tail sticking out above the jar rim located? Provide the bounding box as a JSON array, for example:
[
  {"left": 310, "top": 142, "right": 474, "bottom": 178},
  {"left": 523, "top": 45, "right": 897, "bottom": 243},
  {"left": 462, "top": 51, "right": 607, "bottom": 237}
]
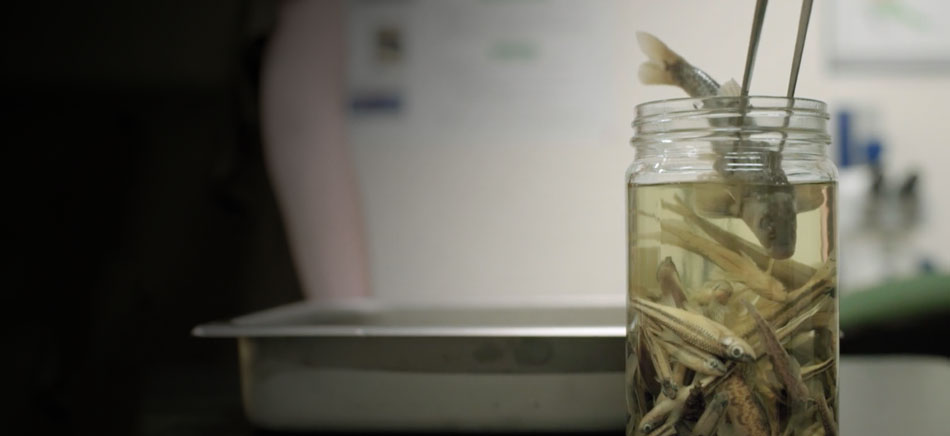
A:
[{"left": 637, "top": 32, "right": 798, "bottom": 259}]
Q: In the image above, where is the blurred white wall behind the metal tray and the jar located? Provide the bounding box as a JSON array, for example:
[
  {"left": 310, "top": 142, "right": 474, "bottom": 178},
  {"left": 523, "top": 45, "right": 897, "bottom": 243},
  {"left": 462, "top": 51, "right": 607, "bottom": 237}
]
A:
[{"left": 350, "top": 0, "right": 950, "bottom": 298}]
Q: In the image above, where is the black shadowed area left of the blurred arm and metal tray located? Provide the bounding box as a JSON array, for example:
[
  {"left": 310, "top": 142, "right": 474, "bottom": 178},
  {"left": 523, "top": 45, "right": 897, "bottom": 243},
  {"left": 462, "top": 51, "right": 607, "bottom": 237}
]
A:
[{"left": 0, "top": 1, "right": 301, "bottom": 435}]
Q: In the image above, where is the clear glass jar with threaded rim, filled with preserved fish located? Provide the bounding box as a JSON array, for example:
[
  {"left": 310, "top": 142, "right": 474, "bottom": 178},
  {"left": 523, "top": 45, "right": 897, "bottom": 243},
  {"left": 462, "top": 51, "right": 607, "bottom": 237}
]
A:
[{"left": 626, "top": 97, "right": 838, "bottom": 436}]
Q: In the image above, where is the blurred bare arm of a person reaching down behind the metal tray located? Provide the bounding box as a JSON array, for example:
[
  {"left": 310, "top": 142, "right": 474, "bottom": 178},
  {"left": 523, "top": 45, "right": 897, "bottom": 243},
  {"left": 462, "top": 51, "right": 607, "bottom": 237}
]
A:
[{"left": 262, "top": 1, "right": 369, "bottom": 298}]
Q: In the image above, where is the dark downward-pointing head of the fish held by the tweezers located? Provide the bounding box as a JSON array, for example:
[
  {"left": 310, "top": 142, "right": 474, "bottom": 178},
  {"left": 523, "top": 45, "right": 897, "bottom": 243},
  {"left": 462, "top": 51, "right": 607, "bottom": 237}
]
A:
[{"left": 742, "top": 190, "right": 798, "bottom": 259}]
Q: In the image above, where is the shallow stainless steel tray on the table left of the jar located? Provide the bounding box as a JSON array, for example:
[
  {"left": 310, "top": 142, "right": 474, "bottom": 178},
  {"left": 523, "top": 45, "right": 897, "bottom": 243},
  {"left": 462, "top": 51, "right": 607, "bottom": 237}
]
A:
[{"left": 193, "top": 296, "right": 626, "bottom": 431}]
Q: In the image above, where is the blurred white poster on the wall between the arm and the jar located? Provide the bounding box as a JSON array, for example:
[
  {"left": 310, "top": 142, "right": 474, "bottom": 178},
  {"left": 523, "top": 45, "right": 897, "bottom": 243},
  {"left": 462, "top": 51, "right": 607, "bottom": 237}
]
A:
[{"left": 349, "top": 1, "right": 613, "bottom": 146}]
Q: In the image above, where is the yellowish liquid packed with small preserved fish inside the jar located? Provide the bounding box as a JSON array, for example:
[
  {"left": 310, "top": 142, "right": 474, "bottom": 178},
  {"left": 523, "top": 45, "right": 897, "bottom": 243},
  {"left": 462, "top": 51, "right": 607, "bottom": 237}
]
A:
[{"left": 627, "top": 182, "right": 838, "bottom": 436}]
